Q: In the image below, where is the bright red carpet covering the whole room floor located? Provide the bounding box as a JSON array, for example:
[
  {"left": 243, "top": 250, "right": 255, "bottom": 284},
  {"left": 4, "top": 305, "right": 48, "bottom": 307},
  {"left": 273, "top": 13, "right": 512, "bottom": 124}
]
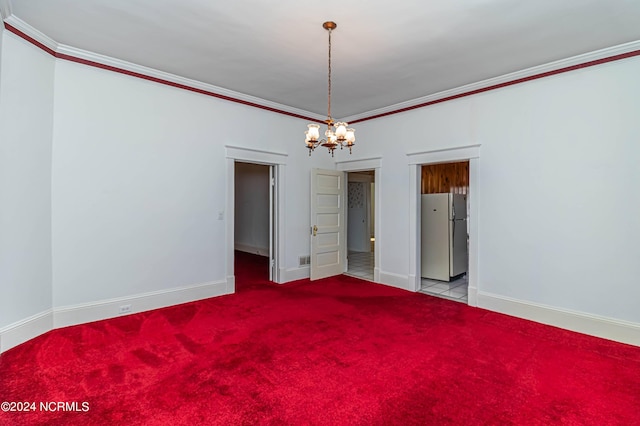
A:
[{"left": 0, "top": 253, "right": 640, "bottom": 425}]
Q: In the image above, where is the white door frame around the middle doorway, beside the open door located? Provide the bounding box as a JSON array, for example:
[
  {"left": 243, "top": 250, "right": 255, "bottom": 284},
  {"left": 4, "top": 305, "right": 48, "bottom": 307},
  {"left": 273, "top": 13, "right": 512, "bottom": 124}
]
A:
[{"left": 336, "top": 157, "right": 383, "bottom": 283}]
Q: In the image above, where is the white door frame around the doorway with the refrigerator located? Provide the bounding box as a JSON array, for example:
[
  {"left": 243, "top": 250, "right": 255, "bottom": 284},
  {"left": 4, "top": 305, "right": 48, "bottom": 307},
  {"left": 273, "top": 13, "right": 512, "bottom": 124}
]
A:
[{"left": 407, "top": 144, "right": 480, "bottom": 306}]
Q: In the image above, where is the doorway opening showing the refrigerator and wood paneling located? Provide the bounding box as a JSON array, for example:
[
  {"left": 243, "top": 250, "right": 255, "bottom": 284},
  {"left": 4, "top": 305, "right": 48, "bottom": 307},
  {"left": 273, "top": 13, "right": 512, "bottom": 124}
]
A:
[{"left": 419, "top": 161, "right": 470, "bottom": 303}]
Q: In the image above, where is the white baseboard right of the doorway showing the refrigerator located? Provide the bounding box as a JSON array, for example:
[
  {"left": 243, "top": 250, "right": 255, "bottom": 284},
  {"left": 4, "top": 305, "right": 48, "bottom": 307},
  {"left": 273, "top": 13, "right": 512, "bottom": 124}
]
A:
[{"left": 477, "top": 291, "right": 640, "bottom": 346}]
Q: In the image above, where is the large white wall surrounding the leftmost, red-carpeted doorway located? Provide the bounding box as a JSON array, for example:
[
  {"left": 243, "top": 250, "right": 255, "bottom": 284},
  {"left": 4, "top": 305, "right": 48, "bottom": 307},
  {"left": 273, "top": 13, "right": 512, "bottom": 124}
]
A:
[{"left": 52, "top": 57, "right": 331, "bottom": 307}]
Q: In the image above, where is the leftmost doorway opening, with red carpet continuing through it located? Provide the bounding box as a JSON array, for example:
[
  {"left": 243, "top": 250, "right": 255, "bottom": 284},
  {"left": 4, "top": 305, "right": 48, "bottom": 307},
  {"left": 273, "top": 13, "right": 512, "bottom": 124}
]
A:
[{"left": 233, "top": 161, "right": 276, "bottom": 284}]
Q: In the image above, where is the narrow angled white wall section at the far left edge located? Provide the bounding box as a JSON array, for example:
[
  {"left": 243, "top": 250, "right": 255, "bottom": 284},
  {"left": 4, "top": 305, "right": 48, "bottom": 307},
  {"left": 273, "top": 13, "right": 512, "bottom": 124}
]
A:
[{"left": 0, "top": 30, "right": 54, "bottom": 330}]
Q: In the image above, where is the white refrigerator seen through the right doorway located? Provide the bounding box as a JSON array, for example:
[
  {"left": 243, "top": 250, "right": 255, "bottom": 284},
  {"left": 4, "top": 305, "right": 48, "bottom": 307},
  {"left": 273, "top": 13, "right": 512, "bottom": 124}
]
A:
[{"left": 421, "top": 194, "right": 469, "bottom": 281}]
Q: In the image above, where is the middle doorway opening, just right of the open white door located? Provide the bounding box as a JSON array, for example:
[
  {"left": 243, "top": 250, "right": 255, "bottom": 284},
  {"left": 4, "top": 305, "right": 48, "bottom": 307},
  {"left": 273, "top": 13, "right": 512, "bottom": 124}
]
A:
[{"left": 346, "top": 170, "right": 376, "bottom": 281}]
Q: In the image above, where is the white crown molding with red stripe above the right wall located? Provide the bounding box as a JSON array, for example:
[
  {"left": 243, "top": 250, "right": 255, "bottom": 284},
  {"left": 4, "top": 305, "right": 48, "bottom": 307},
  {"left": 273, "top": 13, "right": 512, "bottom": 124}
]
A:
[{"left": 341, "top": 40, "right": 640, "bottom": 124}]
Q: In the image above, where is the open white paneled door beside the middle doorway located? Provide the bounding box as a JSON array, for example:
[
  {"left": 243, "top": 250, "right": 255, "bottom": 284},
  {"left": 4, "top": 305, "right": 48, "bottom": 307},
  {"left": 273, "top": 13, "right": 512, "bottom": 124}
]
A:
[{"left": 310, "top": 169, "right": 346, "bottom": 280}]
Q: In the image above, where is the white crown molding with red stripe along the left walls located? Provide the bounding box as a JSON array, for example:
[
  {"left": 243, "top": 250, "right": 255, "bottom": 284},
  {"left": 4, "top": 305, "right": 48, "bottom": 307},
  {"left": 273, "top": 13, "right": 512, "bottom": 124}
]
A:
[{"left": 0, "top": 15, "right": 325, "bottom": 123}]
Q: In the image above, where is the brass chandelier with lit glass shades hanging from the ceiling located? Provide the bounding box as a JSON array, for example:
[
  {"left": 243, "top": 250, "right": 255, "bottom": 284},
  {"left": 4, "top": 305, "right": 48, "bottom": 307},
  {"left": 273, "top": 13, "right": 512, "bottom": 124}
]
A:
[{"left": 304, "top": 21, "right": 356, "bottom": 157}]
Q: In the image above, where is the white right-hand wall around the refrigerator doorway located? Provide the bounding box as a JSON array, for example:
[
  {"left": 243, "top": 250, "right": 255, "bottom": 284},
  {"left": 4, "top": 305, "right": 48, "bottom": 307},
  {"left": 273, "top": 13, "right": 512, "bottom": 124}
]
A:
[{"left": 354, "top": 57, "right": 640, "bottom": 324}]
